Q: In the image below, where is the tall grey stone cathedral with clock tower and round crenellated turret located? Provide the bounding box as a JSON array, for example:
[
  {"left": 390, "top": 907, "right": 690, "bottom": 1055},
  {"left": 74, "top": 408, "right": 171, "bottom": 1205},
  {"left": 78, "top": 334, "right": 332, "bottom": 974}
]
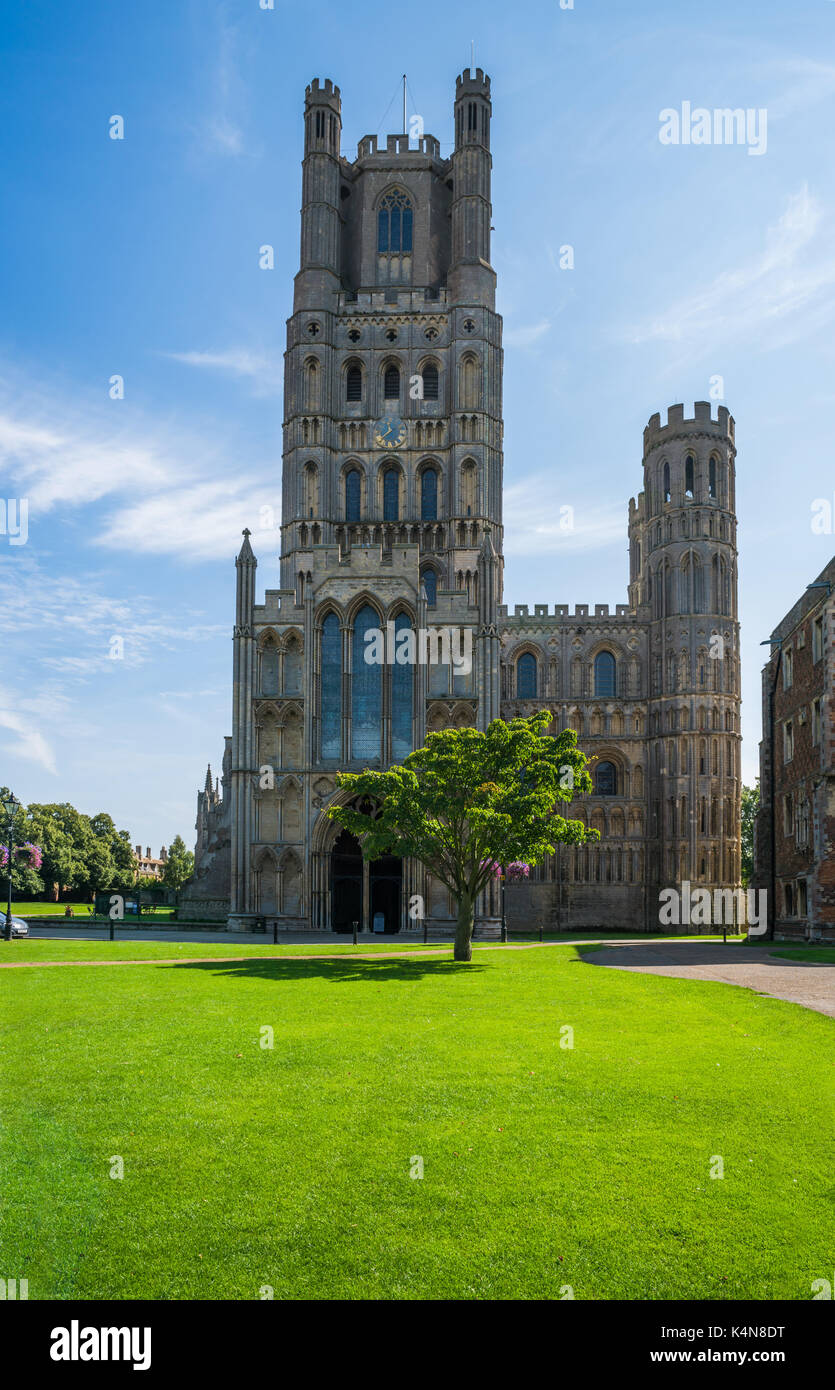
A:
[{"left": 183, "top": 68, "right": 741, "bottom": 934}]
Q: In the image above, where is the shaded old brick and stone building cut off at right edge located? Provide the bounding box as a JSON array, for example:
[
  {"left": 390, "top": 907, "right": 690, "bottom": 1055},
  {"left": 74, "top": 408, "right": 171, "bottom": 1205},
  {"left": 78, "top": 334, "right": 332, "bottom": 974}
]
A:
[{"left": 754, "top": 559, "right": 835, "bottom": 941}]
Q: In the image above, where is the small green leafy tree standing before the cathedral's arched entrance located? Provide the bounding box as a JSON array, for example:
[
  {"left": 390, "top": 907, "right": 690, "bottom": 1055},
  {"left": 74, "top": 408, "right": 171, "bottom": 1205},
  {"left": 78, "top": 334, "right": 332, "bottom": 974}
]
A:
[{"left": 328, "top": 710, "right": 600, "bottom": 960}]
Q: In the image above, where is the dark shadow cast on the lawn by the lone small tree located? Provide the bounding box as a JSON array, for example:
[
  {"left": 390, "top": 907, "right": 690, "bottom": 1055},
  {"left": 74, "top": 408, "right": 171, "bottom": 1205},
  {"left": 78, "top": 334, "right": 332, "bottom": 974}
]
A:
[{"left": 161, "top": 955, "right": 496, "bottom": 984}]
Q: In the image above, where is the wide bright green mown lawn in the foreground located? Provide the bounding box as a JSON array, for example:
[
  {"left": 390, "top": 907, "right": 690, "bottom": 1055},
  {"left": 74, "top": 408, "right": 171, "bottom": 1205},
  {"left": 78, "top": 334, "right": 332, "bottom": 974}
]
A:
[{"left": 0, "top": 942, "right": 835, "bottom": 1300}]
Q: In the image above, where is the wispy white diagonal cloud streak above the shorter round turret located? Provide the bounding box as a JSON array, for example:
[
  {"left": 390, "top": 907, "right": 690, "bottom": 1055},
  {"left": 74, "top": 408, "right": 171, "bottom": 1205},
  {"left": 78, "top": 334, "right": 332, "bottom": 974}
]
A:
[{"left": 628, "top": 185, "right": 835, "bottom": 350}]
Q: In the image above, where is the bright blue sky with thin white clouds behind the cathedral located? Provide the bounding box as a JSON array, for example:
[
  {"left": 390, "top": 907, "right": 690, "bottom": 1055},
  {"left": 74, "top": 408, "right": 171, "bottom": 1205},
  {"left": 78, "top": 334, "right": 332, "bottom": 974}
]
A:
[{"left": 0, "top": 0, "right": 835, "bottom": 852}]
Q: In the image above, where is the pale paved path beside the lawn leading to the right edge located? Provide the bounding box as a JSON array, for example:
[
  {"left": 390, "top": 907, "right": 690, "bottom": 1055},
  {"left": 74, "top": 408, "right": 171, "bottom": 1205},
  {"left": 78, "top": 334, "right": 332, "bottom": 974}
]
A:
[{"left": 581, "top": 941, "right": 835, "bottom": 1019}]
